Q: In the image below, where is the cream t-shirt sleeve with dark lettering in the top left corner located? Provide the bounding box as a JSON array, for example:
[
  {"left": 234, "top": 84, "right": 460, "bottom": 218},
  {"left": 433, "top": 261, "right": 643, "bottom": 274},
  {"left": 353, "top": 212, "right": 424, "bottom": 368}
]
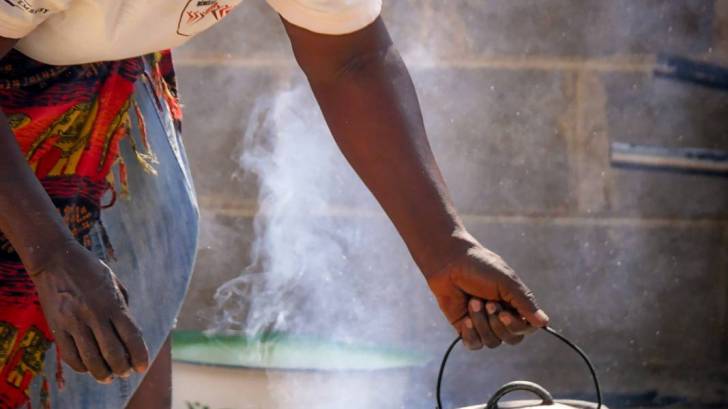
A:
[{"left": 0, "top": 0, "right": 71, "bottom": 38}]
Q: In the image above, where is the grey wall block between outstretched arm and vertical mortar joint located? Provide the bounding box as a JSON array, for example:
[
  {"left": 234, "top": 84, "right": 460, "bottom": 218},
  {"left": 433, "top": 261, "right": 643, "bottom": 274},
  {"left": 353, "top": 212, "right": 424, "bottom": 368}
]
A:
[{"left": 413, "top": 69, "right": 573, "bottom": 214}]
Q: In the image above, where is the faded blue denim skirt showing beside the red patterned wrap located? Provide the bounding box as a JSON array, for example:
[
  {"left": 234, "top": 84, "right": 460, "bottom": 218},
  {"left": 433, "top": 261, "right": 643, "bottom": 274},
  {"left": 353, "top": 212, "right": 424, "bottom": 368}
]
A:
[{"left": 31, "top": 68, "right": 199, "bottom": 409}]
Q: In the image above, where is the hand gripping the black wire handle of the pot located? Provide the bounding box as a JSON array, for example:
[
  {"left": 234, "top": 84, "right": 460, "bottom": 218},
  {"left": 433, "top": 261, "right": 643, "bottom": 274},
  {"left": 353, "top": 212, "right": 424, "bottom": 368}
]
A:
[{"left": 427, "top": 244, "right": 548, "bottom": 349}]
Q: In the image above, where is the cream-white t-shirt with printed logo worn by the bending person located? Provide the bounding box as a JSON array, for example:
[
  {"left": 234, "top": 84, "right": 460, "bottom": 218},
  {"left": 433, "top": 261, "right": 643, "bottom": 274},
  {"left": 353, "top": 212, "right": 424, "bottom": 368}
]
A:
[{"left": 0, "top": 0, "right": 382, "bottom": 65}]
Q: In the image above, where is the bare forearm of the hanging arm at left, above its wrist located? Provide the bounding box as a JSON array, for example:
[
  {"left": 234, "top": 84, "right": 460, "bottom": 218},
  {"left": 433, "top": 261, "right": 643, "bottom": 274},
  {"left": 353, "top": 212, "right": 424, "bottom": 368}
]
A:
[{"left": 0, "top": 112, "right": 73, "bottom": 272}]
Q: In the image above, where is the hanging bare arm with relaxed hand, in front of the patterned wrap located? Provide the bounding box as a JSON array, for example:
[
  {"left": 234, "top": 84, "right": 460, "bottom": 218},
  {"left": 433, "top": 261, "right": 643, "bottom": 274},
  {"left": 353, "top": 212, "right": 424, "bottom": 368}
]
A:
[{"left": 0, "top": 38, "right": 148, "bottom": 382}]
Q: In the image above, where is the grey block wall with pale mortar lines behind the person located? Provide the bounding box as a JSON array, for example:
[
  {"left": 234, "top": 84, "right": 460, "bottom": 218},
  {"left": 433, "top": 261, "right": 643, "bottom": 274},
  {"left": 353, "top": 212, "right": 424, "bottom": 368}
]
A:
[{"left": 176, "top": 0, "right": 728, "bottom": 407}]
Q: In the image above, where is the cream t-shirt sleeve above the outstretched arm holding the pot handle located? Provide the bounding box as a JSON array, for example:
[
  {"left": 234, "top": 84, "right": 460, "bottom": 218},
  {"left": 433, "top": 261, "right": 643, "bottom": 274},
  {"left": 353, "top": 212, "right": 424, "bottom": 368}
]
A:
[{"left": 267, "top": 0, "right": 382, "bottom": 34}]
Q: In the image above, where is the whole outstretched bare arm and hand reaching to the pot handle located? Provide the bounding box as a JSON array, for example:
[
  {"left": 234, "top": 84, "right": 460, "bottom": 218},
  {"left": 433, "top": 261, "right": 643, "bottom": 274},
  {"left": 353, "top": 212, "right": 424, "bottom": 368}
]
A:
[{"left": 284, "top": 19, "right": 548, "bottom": 348}]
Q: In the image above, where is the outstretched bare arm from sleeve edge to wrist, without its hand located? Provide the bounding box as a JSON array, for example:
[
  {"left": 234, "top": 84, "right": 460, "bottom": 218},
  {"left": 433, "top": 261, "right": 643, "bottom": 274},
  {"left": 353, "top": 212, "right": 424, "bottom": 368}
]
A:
[{"left": 288, "top": 23, "right": 474, "bottom": 275}]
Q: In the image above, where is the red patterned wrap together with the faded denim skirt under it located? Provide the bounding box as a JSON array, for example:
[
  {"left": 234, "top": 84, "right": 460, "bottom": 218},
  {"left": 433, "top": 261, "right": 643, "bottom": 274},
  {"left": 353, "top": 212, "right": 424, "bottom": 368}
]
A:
[{"left": 0, "top": 51, "right": 198, "bottom": 409}]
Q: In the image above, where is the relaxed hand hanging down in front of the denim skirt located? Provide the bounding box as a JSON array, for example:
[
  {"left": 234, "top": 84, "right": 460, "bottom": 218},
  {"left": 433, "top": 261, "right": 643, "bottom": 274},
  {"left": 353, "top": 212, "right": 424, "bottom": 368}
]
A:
[{"left": 28, "top": 242, "right": 148, "bottom": 383}]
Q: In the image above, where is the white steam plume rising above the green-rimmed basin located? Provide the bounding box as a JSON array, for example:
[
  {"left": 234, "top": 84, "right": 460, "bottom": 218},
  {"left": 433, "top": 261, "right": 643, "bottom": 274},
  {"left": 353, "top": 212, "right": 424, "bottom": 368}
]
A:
[{"left": 216, "top": 85, "right": 396, "bottom": 339}]
